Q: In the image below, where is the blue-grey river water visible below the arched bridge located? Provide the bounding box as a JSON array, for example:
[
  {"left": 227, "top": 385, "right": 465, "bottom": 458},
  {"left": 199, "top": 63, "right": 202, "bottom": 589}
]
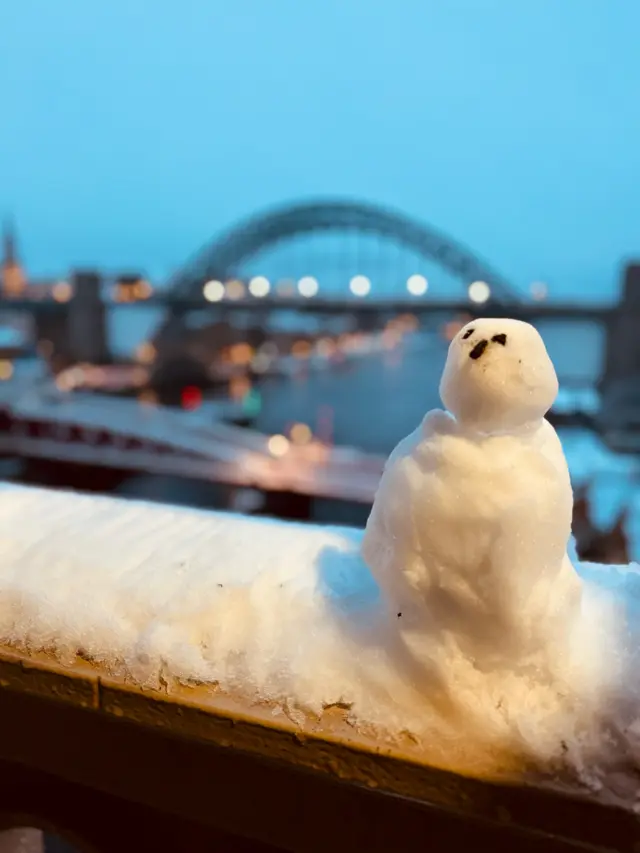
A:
[{"left": 109, "top": 306, "right": 604, "bottom": 453}]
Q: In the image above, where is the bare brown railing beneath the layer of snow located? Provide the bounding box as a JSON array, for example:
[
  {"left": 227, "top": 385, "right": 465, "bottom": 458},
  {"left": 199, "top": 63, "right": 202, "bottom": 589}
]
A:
[{"left": 0, "top": 650, "right": 640, "bottom": 853}]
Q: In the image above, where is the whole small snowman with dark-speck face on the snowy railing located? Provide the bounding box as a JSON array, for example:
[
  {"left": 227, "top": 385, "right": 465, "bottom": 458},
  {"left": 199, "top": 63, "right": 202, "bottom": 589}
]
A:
[{"left": 363, "top": 319, "right": 581, "bottom": 670}]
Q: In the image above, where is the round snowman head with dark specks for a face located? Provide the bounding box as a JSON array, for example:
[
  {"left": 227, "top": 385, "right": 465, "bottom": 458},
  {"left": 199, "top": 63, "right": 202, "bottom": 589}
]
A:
[{"left": 440, "top": 319, "right": 558, "bottom": 433}]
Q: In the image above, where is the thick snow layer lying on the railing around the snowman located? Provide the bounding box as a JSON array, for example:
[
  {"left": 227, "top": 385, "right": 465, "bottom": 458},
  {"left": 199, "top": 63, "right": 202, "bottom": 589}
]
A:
[{"left": 0, "top": 485, "right": 640, "bottom": 796}]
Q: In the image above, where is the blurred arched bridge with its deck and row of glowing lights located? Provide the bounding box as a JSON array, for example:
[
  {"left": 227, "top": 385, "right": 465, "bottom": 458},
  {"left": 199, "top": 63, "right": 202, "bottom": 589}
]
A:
[{"left": 0, "top": 200, "right": 613, "bottom": 332}]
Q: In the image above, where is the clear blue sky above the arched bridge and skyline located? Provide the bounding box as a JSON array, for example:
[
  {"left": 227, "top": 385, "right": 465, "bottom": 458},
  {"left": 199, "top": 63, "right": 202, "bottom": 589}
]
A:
[{"left": 0, "top": 0, "right": 640, "bottom": 297}]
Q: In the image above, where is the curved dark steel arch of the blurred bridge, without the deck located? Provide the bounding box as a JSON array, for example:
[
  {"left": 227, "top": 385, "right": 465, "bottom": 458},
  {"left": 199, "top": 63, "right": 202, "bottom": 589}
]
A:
[{"left": 170, "top": 200, "right": 520, "bottom": 302}]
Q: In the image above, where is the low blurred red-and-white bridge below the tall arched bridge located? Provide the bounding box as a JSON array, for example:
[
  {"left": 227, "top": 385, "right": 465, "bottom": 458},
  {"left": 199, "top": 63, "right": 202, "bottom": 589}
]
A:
[{"left": 0, "top": 388, "right": 384, "bottom": 504}]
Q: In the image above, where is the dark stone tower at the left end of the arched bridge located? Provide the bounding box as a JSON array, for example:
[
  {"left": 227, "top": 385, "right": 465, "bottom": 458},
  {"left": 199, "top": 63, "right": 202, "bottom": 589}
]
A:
[{"left": 67, "top": 271, "right": 109, "bottom": 364}]
